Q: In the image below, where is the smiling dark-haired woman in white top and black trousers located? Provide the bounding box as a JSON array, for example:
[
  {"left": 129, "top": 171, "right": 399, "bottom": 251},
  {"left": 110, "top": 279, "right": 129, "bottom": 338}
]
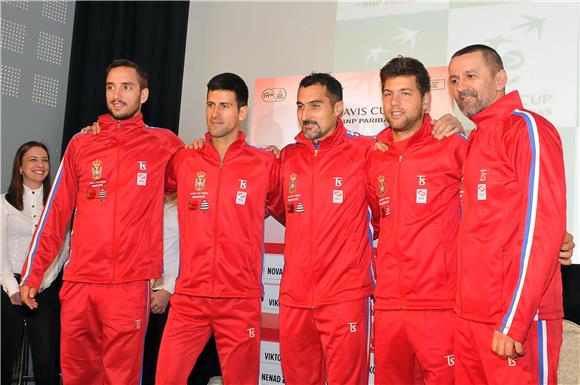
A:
[{"left": 0, "top": 141, "right": 68, "bottom": 385}]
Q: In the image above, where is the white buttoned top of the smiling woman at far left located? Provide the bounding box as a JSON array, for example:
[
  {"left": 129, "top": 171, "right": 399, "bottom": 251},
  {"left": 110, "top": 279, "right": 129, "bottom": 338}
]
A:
[{"left": 0, "top": 185, "right": 69, "bottom": 296}]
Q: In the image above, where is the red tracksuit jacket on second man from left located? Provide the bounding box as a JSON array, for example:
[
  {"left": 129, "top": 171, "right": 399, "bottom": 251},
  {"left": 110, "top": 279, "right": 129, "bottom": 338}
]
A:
[{"left": 167, "top": 132, "right": 280, "bottom": 298}]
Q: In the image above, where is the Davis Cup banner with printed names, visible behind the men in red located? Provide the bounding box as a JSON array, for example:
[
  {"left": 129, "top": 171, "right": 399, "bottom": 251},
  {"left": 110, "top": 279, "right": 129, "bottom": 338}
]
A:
[{"left": 249, "top": 67, "right": 453, "bottom": 385}]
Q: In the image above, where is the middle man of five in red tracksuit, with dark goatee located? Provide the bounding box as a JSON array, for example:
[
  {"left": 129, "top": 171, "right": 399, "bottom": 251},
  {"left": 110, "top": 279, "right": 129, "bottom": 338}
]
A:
[{"left": 279, "top": 73, "right": 374, "bottom": 385}]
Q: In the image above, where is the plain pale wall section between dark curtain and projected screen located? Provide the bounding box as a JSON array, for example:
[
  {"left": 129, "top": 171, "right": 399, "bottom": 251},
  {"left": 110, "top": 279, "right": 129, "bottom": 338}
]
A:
[{"left": 179, "top": 1, "right": 336, "bottom": 142}]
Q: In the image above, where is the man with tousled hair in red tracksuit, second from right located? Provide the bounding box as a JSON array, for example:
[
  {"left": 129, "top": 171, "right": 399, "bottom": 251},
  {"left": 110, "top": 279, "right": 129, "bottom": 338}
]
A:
[{"left": 367, "top": 56, "right": 466, "bottom": 385}]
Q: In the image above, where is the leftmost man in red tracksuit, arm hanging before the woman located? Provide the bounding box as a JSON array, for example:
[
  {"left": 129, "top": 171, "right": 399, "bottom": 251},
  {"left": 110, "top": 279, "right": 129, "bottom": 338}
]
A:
[{"left": 21, "top": 60, "right": 183, "bottom": 385}]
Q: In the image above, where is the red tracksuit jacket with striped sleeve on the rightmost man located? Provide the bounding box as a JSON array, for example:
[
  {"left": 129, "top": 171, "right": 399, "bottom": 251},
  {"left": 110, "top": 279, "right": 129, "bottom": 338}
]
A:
[{"left": 456, "top": 91, "right": 566, "bottom": 342}]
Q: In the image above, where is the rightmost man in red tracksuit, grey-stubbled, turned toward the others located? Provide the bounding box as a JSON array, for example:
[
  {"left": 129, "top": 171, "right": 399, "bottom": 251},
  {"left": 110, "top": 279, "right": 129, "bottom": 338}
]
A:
[{"left": 449, "top": 45, "right": 566, "bottom": 385}]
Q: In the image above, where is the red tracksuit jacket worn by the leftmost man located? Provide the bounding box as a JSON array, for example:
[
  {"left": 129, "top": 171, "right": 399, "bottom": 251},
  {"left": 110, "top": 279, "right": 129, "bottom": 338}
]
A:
[{"left": 22, "top": 114, "right": 183, "bottom": 288}]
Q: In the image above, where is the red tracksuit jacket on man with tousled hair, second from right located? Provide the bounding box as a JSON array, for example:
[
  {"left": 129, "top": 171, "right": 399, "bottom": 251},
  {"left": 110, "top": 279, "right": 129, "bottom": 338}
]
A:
[{"left": 367, "top": 115, "right": 466, "bottom": 310}]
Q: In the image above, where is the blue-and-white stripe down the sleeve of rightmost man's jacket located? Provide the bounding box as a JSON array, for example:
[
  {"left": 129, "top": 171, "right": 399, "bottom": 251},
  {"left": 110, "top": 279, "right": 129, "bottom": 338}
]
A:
[{"left": 500, "top": 111, "right": 536, "bottom": 330}]
